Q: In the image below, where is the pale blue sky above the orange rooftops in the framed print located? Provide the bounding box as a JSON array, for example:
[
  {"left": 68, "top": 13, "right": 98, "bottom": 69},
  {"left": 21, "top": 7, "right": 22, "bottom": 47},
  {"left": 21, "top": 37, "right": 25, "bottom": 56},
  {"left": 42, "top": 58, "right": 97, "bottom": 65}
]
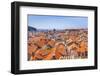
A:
[{"left": 28, "top": 15, "right": 88, "bottom": 29}]
